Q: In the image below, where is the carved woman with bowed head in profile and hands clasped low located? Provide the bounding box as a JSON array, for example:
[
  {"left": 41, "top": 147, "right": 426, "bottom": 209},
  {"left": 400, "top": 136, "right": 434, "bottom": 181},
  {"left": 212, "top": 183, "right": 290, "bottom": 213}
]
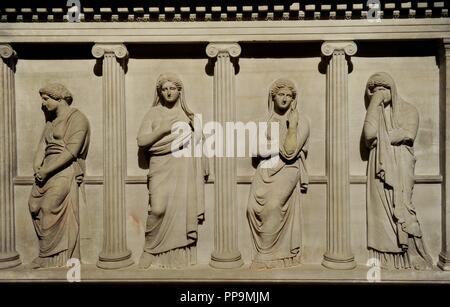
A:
[{"left": 28, "top": 83, "right": 90, "bottom": 268}]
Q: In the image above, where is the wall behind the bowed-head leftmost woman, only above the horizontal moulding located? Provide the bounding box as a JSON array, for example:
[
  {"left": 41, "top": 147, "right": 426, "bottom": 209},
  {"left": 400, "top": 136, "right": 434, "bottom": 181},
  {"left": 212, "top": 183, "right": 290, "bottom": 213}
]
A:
[{"left": 16, "top": 59, "right": 103, "bottom": 176}]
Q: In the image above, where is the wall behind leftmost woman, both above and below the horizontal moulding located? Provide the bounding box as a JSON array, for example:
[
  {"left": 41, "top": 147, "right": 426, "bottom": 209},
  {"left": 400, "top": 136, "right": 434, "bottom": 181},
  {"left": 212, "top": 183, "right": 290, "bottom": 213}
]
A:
[{"left": 15, "top": 56, "right": 103, "bottom": 263}]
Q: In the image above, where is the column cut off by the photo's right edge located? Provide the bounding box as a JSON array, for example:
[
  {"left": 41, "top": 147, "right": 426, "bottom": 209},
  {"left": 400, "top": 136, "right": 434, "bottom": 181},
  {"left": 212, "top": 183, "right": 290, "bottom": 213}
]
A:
[{"left": 437, "top": 38, "right": 450, "bottom": 271}]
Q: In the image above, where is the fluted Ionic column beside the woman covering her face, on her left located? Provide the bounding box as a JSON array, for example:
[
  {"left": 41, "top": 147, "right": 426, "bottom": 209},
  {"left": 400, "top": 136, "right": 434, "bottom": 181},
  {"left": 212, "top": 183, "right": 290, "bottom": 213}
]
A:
[{"left": 321, "top": 42, "right": 356, "bottom": 269}]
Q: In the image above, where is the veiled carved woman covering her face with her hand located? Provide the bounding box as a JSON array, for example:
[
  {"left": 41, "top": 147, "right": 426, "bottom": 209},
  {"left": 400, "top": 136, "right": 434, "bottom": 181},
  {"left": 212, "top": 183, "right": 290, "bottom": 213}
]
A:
[{"left": 363, "top": 72, "right": 432, "bottom": 269}]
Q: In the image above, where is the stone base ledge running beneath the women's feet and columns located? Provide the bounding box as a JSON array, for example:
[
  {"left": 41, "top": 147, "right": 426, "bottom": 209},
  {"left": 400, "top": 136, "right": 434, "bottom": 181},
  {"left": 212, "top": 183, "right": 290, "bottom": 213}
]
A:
[{"left": 0, "top": 264, "right": 450, "bottom": 283}]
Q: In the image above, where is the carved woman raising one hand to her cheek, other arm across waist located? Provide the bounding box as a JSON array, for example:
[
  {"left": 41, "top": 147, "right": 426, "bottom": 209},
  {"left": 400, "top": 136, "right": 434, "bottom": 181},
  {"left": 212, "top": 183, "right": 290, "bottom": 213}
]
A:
[{"left": 247, "top": 79, "right": 309, "bottom": 269}]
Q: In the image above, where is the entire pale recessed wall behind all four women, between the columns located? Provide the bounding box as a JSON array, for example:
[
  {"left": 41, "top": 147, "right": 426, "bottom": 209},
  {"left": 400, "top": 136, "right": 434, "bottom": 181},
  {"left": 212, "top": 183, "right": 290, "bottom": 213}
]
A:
[{"left": 11, "top": 43, "right": 441, "bottom": 265}]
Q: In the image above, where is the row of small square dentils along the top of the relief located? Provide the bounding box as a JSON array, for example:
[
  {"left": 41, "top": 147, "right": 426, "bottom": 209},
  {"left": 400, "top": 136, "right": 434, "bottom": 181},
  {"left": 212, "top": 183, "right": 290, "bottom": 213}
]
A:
[{"left": 0, "top": 0, "right": 448, "bottom": 22}]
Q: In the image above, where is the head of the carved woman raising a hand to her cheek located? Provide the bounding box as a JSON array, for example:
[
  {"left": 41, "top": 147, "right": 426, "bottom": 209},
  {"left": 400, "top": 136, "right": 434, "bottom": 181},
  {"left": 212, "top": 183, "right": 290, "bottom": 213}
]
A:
[{"left": 269, "top": 79, "right": 297, "bottom": 113}]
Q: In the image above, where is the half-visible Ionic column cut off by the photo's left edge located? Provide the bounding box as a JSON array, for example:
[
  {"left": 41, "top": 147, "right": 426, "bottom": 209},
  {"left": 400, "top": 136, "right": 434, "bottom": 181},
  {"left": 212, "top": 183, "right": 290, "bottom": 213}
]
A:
[{"left": 0, "top": 45, "right": 21, "bottom": 269}]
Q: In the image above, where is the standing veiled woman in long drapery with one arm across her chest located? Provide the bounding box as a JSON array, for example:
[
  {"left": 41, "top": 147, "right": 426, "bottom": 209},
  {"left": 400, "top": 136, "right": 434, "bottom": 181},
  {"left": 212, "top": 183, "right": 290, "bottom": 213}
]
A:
[{"left": 137, "top": 74, "right": 204, "bottom": 268}]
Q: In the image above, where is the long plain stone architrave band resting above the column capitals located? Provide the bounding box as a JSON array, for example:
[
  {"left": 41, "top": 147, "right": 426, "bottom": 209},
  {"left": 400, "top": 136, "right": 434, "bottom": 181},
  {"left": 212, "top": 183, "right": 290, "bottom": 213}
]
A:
[{"left": 0, "top": 18, "right": 450, "bottom": 43}]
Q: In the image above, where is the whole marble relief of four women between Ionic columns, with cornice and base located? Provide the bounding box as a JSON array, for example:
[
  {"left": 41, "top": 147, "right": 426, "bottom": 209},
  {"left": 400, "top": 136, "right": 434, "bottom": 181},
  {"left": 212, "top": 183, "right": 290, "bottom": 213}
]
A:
[{"left": 0, "top": 1, "right": 450, "bottom": 282}]
